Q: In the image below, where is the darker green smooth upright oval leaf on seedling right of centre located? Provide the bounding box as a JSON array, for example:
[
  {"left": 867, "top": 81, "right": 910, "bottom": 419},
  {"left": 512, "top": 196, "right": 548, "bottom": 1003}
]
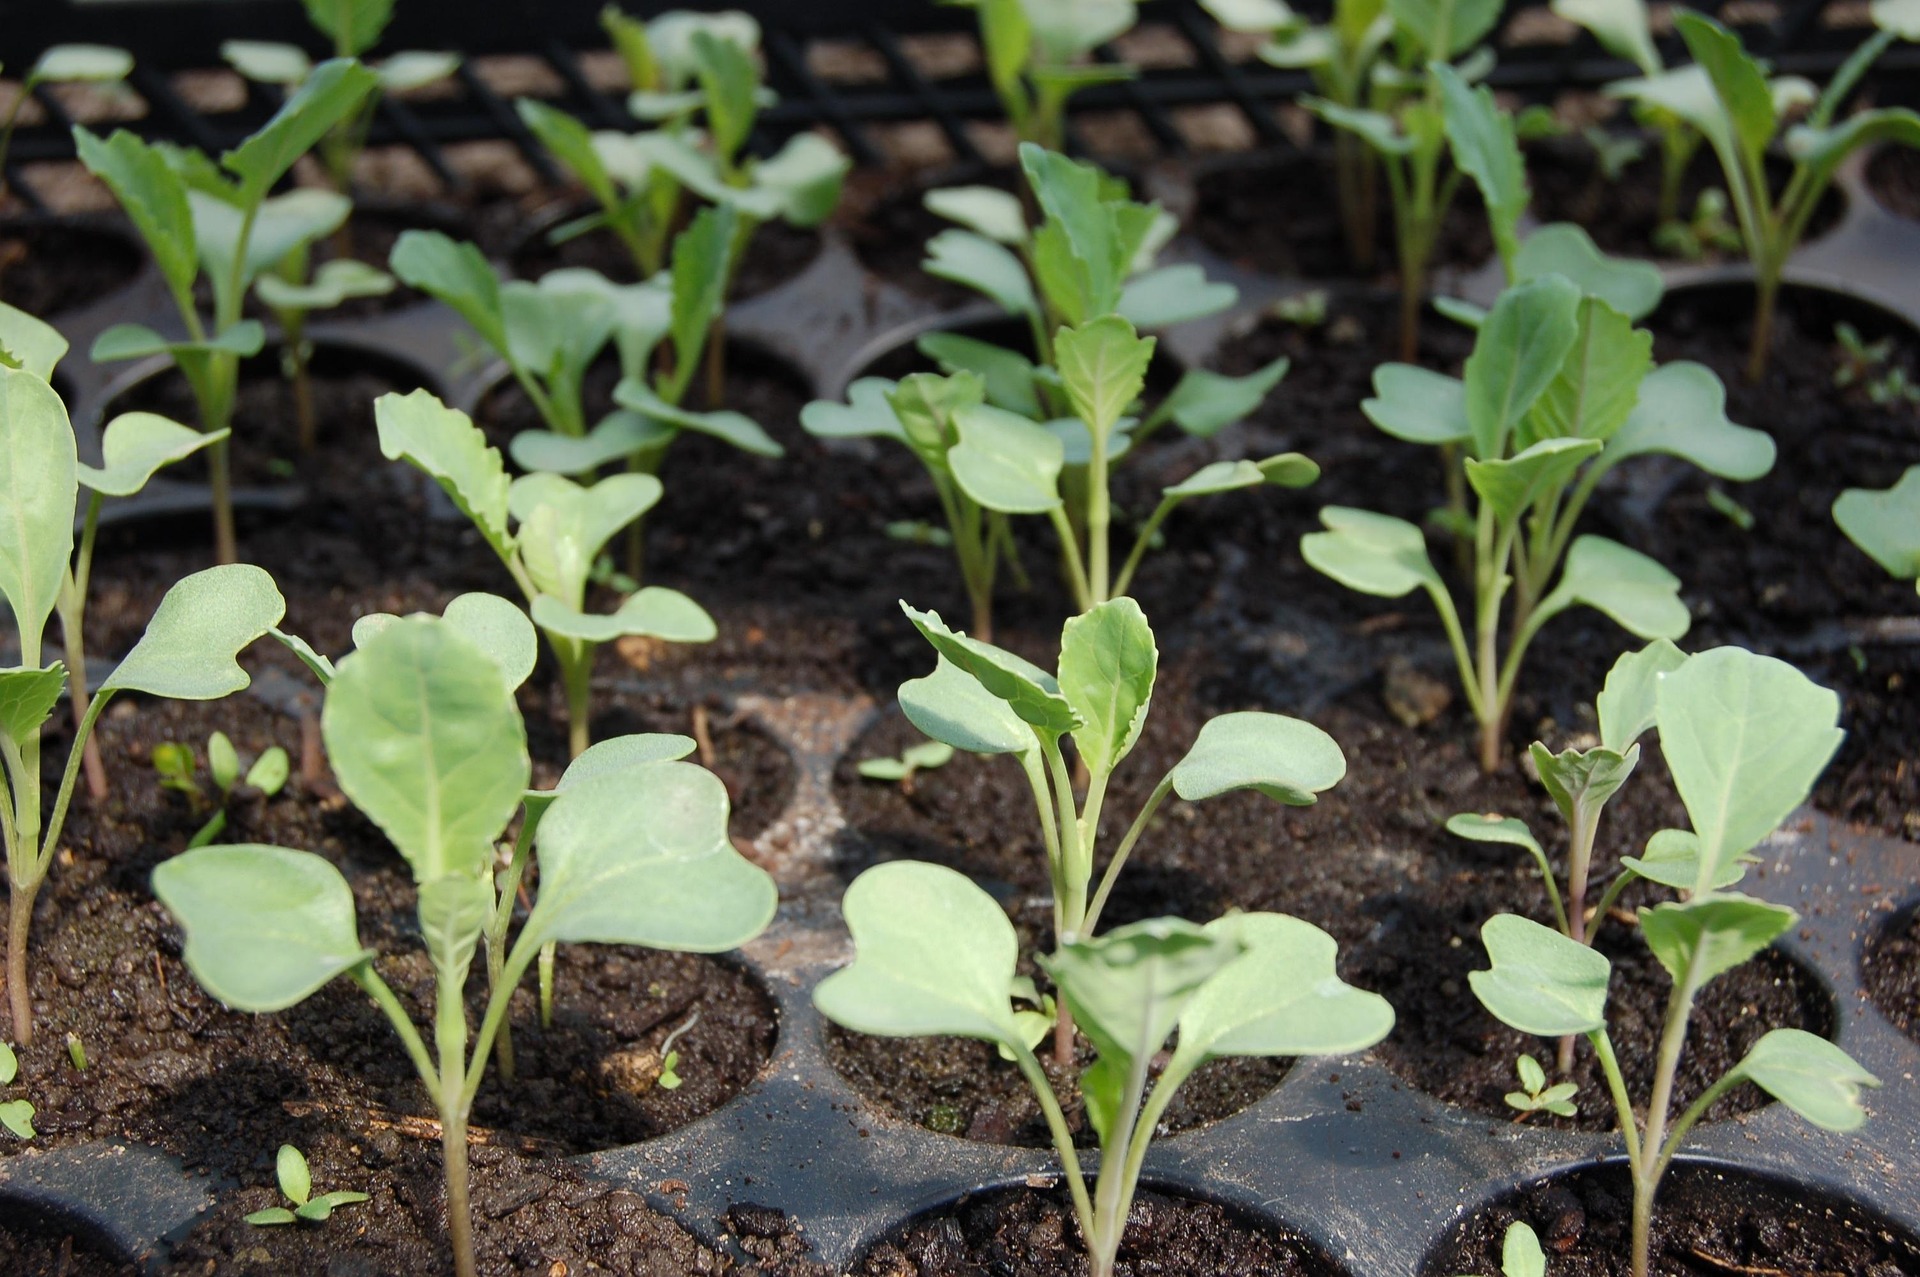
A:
[{"left": 1463, "top": 275, "right": 1580, "bottom": 461}]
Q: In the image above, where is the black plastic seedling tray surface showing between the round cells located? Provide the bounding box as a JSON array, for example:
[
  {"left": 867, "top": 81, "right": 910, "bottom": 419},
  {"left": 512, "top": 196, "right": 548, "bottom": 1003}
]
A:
[{"left": 0, "top": 146, "right": 1920, "bottom": 1277}]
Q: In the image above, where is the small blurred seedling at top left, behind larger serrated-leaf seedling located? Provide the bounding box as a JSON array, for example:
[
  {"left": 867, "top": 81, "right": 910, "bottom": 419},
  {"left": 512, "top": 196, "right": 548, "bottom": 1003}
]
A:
[{"left": 221, "top": 0, "right": 461, "bottom": 204}]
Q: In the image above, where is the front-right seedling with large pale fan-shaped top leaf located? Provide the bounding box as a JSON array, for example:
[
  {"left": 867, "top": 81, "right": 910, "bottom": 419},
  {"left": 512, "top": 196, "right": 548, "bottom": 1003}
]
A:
[{"left": 1469, "top": 647, "right": 1880, "bottom": 1277}]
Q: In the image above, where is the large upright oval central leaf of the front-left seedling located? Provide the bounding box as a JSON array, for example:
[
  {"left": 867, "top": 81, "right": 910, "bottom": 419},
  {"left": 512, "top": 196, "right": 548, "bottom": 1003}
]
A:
[{"left": 321, "top": 616, "right": 530, "bottom": 883}]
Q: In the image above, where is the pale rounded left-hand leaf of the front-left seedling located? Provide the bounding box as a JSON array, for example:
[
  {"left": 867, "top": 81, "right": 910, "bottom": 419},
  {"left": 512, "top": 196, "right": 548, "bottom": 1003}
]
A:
[{"left": 154, "top": 843, "right": 374, "bottom": 1012}]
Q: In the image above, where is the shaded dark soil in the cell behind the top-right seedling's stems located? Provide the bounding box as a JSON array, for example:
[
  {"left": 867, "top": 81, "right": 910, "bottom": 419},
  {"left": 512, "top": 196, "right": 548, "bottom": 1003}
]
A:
[{"left": 1526, "top": 138, "right": 1847, "bottom": 261}]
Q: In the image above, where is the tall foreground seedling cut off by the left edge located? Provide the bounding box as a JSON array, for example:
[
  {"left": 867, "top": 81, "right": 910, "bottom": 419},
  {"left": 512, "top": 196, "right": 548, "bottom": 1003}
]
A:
[{"left": 0, "top": 353, "right": 286, "bottom": 1045}]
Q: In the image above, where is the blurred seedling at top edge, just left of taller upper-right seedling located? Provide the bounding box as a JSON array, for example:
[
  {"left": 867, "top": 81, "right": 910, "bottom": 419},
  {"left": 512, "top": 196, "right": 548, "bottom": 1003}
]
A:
[{"left": 1200, "top": 0, "right": 1404, "bottom": 273}]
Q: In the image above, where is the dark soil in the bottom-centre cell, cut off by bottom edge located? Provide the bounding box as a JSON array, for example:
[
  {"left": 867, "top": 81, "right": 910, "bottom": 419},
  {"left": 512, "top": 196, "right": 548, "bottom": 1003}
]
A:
[{"left": 852, "top": 1187, "right": 1340, "bottom": 1277}]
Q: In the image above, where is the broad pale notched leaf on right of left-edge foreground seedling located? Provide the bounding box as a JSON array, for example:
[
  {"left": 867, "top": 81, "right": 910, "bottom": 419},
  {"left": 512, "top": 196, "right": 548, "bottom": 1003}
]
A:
[{"left": 100, "top": 563, "right": 286, "bottom": 701}]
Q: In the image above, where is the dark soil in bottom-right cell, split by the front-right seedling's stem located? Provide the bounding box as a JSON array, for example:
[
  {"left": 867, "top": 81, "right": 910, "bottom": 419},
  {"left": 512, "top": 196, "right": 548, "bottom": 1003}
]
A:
[{"left": 1421, "top": 1162, "right": 1920, "bottom": 1277}]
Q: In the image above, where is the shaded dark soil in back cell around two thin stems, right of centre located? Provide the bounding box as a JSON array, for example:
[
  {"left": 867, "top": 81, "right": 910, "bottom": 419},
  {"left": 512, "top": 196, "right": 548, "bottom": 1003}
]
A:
[{"left": 1192, "top": 150, "right": 1494, "bottom": 278}]
